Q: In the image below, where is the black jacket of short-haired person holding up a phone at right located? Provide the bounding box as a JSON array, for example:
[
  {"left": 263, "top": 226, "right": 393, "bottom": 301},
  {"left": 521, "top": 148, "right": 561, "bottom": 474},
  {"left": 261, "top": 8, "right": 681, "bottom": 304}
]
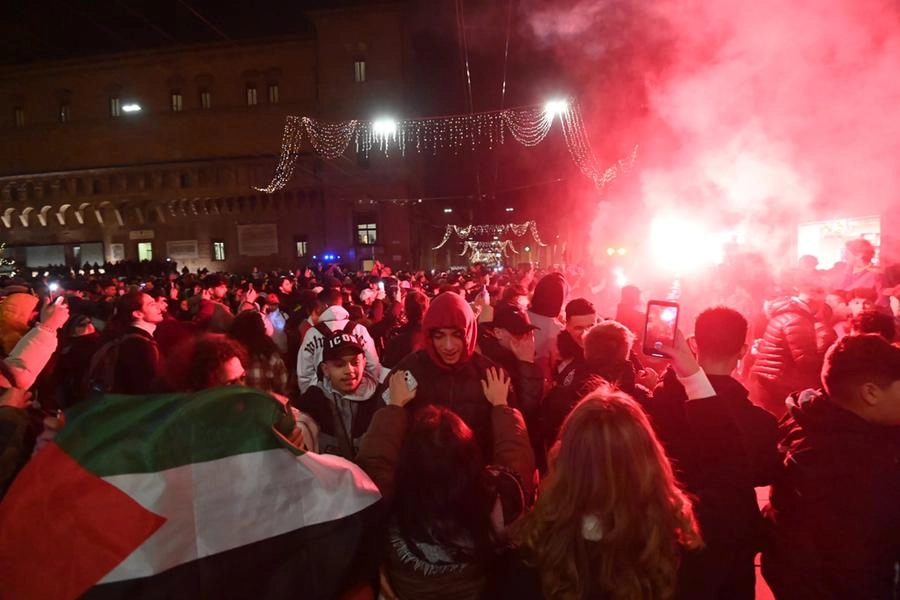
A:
[{"left": 646, "top": 369, "right": 779, "bottom": 599}]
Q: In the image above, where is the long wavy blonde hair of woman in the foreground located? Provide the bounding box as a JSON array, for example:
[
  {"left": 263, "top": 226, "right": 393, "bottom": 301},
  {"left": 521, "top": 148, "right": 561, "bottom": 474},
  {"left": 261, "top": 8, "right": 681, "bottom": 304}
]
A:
[{"left": 512, "top": 385, "right": 702, "bottom": 599}]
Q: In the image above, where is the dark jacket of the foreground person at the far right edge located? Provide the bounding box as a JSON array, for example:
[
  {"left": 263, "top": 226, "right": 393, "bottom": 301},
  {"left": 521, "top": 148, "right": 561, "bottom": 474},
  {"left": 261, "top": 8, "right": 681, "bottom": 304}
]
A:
[{"left": 762, "top": 390, "right": 900, "bottom": 600}]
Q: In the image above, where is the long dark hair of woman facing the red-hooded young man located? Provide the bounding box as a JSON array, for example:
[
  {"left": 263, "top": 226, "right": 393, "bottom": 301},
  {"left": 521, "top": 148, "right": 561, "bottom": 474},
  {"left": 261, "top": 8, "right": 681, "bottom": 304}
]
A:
[{"left": 393, "top": 406, "right": 497, "bottom": 562}]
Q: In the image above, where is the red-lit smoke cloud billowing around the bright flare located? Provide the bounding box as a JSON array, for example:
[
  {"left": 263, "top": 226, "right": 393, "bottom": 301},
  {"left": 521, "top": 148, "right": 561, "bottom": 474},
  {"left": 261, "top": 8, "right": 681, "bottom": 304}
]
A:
[{"left": 528, "top": 0, "right": 900, "bottom": 278}]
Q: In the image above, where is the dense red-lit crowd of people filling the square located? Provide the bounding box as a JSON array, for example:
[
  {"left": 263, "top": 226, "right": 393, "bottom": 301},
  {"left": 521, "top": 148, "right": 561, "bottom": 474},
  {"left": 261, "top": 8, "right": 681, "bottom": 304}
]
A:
[{"left": 0, "top": 240, "right": 900, "bottom": 600}]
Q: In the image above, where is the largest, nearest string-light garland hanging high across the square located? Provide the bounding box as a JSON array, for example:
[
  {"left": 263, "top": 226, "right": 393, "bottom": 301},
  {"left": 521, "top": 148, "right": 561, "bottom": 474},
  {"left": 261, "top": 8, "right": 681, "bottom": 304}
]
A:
[{"left": 253, "top": 101, "right": 637, "bottom": 194}]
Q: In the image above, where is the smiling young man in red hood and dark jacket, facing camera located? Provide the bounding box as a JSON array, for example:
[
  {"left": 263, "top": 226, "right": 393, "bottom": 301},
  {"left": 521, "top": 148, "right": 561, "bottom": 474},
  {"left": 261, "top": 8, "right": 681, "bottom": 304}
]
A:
[{"left": 379, "top": 293, "right": 518, "bottom": 457}]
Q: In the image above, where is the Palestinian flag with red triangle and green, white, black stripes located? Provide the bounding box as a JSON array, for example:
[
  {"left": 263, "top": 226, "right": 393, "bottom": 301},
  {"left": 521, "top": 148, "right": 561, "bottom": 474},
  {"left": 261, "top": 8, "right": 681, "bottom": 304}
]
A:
[{"left": 0, "top": 387, "right": 380, "bottom": 600}]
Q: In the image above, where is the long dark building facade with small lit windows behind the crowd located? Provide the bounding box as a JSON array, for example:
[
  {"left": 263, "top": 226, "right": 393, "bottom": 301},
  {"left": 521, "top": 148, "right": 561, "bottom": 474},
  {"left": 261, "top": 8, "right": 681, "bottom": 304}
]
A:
[{"left": 0, "top": 4, "right": 420, "bottom": 271}]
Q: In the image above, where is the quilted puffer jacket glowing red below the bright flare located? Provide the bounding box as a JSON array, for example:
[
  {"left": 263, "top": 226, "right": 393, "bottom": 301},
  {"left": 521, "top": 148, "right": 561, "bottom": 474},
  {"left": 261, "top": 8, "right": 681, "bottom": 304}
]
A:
[{"left": 752, "top": 298, "right": 823, "bottom": 390}]
